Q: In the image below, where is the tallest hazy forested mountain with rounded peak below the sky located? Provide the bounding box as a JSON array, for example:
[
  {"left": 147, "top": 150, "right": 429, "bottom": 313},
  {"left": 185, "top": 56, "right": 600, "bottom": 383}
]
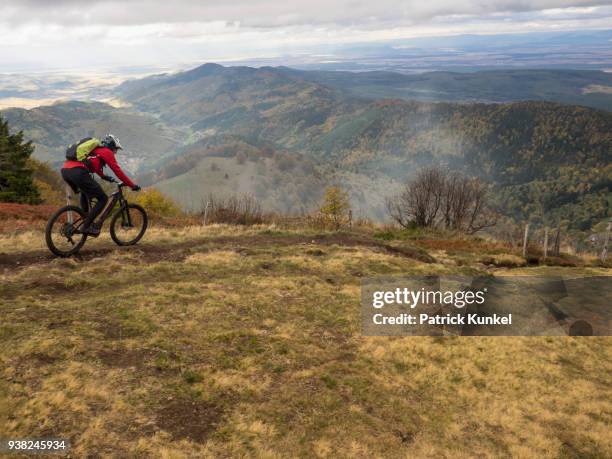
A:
[{"left": 117, "top": 64, "right": 354, "bottom": 133}]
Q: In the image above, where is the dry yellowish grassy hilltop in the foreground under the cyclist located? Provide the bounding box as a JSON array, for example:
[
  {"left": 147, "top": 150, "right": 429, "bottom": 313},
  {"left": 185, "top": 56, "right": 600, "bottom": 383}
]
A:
[{"left": 0, "top": 217, "right": 612, "bottom": 457}]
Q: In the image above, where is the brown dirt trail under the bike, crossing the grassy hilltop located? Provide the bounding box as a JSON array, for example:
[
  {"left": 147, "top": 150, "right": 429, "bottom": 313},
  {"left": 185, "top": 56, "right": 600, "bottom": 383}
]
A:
[{"left": 0, "top": 233, "right": 434, "bottom": 271}]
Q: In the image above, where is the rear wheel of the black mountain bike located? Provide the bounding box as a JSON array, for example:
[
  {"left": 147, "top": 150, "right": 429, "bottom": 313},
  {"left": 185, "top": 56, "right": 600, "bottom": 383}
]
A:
[{"left": 45, "top": 206, "right": 87, "bottom": 257}]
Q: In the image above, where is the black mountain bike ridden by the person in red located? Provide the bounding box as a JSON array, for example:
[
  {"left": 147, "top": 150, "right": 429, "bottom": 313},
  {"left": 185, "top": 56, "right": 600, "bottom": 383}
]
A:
[{"left": 45, "top": 183, "right": 149, "bottom": 257}]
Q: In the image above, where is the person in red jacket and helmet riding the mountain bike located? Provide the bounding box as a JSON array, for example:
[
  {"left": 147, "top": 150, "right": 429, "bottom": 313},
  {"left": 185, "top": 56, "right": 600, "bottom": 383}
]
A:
[{"left": 61, "top": 134, "right": 140, "bottom": 236}]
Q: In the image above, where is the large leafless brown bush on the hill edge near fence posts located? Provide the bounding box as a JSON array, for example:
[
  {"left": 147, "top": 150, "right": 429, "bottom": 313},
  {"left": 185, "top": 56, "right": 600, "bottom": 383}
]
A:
[{"left": 386, "top": 167, "right": 496, "bottom": 234}]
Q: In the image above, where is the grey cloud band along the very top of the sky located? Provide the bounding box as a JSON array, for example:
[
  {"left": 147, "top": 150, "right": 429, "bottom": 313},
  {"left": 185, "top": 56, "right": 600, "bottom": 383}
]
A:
[{"left": 2, "top": 0, "right": 611, "bottom": 28}]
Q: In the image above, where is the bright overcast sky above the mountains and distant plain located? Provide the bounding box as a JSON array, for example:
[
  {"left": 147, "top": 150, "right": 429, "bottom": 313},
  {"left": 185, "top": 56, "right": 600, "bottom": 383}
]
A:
[{"left": 0, "top": 0, "right": 612, "bottom": 72}]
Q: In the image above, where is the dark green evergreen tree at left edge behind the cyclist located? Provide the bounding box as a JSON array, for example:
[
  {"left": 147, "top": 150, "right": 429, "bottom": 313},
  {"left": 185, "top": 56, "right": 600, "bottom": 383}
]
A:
[{"left": 0, "top": 117, "right": 41, "bottom": 204}]
